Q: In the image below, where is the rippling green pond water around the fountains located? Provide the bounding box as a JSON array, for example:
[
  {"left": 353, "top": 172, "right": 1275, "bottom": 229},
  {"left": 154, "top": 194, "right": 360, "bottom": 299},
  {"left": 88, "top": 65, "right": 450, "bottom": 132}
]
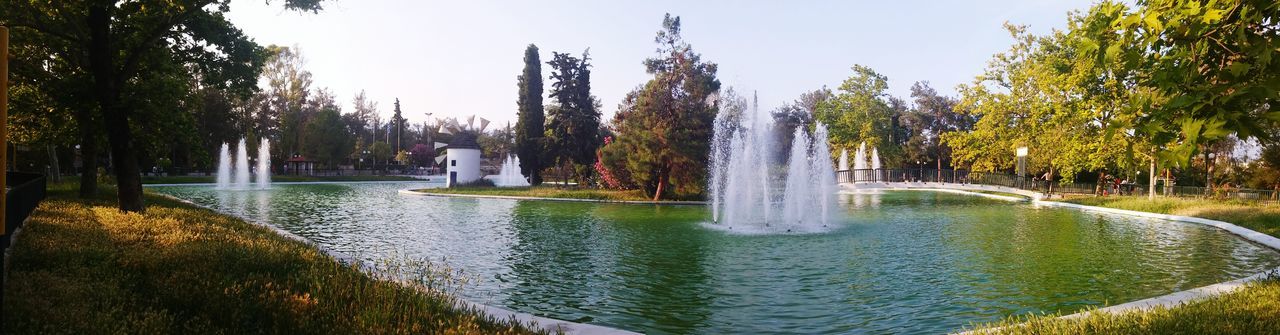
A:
[{"left": 154, "top": 183, "right": 1280, "bottom": 334}]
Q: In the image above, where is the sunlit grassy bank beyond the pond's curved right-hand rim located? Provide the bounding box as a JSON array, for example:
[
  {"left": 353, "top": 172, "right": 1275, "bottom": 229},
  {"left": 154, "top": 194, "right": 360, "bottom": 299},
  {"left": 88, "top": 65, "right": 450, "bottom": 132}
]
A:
[{"left": 1066, "top": 197, "right": 1280, "bottom": 237}]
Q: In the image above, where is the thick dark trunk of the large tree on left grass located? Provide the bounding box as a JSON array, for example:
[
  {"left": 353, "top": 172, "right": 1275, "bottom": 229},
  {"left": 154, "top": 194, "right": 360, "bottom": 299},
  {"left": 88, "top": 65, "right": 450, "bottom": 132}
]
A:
[{"left": 88, "top": 4, "right": 145, "bottom": 212}]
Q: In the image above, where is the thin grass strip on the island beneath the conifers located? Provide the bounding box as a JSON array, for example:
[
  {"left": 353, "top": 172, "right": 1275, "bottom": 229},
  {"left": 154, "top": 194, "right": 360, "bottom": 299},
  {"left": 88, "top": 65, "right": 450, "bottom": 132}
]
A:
[{"left": 417, "top": 185, "right": 653, "bottom": 201}]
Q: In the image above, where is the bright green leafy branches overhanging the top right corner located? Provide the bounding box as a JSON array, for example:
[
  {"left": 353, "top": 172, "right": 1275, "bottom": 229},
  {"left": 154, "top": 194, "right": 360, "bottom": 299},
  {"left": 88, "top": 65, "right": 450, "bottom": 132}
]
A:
[{"left": 1088, "top": 0, "right": 1280, "bottom": 165}]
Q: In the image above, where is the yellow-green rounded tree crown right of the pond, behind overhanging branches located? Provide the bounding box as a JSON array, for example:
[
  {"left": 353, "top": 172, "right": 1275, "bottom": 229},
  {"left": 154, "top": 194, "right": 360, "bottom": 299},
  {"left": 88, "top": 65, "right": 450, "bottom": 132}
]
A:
[{"left": 942, "top": 11, "right": 1153, "bottom": 182}]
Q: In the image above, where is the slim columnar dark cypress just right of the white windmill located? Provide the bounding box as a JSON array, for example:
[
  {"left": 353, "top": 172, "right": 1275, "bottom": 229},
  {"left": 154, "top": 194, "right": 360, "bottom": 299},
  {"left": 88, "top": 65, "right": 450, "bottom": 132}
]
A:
[{"left": 516, "top": 45, "right": 547, "bottom": 185}]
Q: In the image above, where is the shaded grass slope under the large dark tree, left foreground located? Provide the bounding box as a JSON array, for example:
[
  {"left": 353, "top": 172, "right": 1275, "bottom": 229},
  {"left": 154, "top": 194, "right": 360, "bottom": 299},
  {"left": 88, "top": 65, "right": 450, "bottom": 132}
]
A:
[{"left": 4, "top": 183, "right": 547, "bottom": 334}]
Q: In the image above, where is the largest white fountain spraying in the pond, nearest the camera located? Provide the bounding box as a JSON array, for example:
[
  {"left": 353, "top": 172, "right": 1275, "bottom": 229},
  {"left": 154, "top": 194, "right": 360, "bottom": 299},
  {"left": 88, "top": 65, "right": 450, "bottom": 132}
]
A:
[{"left": 708, "top": 98, "right": 836, "bottom": 233}]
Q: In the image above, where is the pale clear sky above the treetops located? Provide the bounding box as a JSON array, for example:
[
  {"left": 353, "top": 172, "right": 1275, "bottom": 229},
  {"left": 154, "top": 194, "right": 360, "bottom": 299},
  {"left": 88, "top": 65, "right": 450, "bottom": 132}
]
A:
[{"left": 228, "top": 0, "right": 1091, "bottom": 129}]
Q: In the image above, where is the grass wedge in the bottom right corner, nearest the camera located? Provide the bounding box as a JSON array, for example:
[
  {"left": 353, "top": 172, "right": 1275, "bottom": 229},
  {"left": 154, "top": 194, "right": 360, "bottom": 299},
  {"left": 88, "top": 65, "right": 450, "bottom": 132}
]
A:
[{"left": 975, "top": 279, "right": 1280, "bottom": 335}]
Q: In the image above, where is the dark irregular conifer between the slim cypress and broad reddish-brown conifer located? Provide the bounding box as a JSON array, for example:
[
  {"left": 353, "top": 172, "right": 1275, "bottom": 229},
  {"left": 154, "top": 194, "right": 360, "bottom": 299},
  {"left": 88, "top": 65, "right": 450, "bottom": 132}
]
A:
[{"left": 547, "top": 51, "right": 600, "bottom": 184}]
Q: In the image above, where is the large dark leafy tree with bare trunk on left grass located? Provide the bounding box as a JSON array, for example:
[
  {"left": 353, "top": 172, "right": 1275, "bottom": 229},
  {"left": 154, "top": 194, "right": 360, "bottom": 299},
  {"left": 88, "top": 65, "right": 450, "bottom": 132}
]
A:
[{"left": 0, "top": 0, "right": 320, "bottom": 211}]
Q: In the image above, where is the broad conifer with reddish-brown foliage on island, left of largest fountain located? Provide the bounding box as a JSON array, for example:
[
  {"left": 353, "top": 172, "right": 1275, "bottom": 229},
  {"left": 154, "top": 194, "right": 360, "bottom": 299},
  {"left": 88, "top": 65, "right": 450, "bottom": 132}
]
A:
[{"left": 605, "top": 14, "right": 721, "bottom": 199}]
